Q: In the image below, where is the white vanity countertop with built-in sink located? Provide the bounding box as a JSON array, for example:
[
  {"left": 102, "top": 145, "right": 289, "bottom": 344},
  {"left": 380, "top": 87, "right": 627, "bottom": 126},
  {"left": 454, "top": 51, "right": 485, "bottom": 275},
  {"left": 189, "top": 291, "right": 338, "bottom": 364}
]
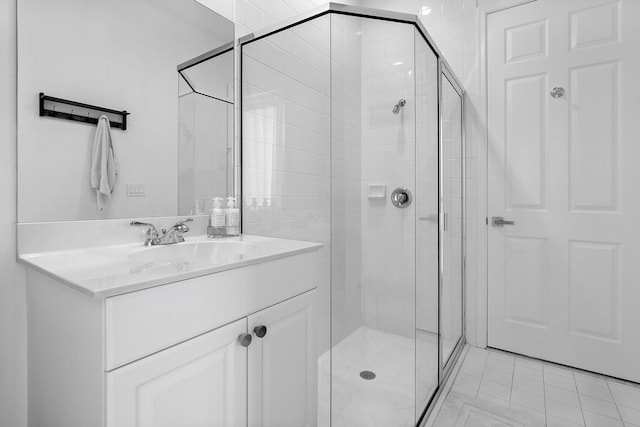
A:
[{"left": 20, "top": 235, "right": 322, "bottom": 298}]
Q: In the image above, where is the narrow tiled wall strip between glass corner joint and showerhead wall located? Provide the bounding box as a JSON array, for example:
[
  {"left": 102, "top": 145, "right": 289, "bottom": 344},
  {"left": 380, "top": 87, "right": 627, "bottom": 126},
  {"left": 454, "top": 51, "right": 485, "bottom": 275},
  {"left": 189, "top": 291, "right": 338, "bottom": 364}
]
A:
[{"left": 331, "top": 15, "right": 363, "bottom": 344}]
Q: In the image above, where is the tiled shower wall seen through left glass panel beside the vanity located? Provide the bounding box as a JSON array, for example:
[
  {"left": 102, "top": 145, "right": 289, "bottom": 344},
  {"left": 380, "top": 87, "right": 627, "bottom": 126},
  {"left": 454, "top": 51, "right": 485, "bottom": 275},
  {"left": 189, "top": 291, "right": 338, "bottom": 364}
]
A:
[{"left": 242, "top": 15, "right": 331, "bottom": 351}]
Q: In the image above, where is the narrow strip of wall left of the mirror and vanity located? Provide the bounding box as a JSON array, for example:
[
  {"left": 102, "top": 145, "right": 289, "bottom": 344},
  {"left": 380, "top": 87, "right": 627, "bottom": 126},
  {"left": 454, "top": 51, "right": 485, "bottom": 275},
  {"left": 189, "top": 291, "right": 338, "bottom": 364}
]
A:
[{"left": 0, "top": 0, "right": 27, "bottom": 427}]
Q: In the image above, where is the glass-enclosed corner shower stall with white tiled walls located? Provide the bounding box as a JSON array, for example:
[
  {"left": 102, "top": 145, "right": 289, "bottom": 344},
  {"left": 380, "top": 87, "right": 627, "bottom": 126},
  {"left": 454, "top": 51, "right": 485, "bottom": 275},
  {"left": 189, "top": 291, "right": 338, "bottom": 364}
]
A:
[{"left": 239, "top": 3, "right": 464, "bottom": 427}]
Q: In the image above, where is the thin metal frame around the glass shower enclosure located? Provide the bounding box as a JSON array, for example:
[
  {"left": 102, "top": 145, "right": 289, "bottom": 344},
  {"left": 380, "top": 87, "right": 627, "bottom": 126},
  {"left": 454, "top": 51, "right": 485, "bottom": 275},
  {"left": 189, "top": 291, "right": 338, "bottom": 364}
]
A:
[{"left": 236, "top": 3, "right": 466, "bottom": 427}]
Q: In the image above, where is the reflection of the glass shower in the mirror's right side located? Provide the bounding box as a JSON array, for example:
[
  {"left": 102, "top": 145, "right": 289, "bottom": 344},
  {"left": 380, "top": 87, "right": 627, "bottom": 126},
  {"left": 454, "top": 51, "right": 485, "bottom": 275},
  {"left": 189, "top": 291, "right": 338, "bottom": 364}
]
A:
[{"left": 178, "top": 43, "right": 234, "bottom": 215}]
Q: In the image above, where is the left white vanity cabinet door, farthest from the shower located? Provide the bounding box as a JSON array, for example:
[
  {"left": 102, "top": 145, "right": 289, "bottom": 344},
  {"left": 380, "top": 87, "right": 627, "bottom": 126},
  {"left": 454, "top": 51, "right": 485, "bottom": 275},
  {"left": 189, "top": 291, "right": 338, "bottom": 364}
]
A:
[{"left": 107, "top": 318, "right": 247, "bottom": 427}]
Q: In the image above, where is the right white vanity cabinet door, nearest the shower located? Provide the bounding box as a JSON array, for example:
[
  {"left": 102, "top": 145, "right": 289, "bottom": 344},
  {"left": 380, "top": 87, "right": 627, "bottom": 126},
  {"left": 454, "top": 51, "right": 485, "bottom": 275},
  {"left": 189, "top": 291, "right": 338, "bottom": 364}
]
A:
[{"left": 248, "top": 290, "right": 318, "bottom": 427}]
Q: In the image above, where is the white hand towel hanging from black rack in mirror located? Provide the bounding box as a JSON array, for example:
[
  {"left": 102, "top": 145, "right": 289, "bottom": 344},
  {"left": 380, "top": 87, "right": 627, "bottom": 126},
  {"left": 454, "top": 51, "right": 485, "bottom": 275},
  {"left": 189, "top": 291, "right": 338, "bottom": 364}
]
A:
[{"left": 91, "top": 115, "right": 120, "bottom": 210}]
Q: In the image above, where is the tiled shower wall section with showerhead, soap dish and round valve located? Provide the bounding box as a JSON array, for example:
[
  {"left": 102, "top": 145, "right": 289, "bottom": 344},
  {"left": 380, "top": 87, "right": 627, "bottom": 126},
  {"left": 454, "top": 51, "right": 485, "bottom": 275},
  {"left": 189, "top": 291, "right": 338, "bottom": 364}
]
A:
[{"left": 361, "top": 19, "right": 416, "bottom": 337}]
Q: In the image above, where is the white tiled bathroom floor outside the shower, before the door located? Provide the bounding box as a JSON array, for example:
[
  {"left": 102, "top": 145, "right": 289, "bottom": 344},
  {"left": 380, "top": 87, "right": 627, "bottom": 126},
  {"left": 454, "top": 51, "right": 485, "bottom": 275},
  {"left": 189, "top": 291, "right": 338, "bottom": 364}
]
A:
[{"left": 428, "top": 347, "right": 640, "bottom": 427}]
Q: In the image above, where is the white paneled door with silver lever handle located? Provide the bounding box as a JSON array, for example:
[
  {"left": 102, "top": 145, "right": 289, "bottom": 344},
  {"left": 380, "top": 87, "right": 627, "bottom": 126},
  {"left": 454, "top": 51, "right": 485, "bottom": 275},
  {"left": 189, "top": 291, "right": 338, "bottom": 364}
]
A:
[{"left": 487, "top": 0, "right": 640, "bottom": 381}]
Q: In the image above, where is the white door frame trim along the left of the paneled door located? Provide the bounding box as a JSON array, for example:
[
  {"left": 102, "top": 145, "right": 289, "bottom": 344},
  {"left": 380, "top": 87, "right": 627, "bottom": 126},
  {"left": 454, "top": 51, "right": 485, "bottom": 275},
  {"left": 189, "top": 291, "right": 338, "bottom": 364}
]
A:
[{"left": 475, "top": 0, "right": 538, "bottom": 348}]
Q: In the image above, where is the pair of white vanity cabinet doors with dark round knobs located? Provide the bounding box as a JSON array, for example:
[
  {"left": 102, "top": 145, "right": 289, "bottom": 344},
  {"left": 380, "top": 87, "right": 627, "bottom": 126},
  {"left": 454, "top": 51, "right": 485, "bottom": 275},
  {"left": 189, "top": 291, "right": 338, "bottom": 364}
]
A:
[{"left": 106, "top": 291, "right": 317, "bottom": 427}]
